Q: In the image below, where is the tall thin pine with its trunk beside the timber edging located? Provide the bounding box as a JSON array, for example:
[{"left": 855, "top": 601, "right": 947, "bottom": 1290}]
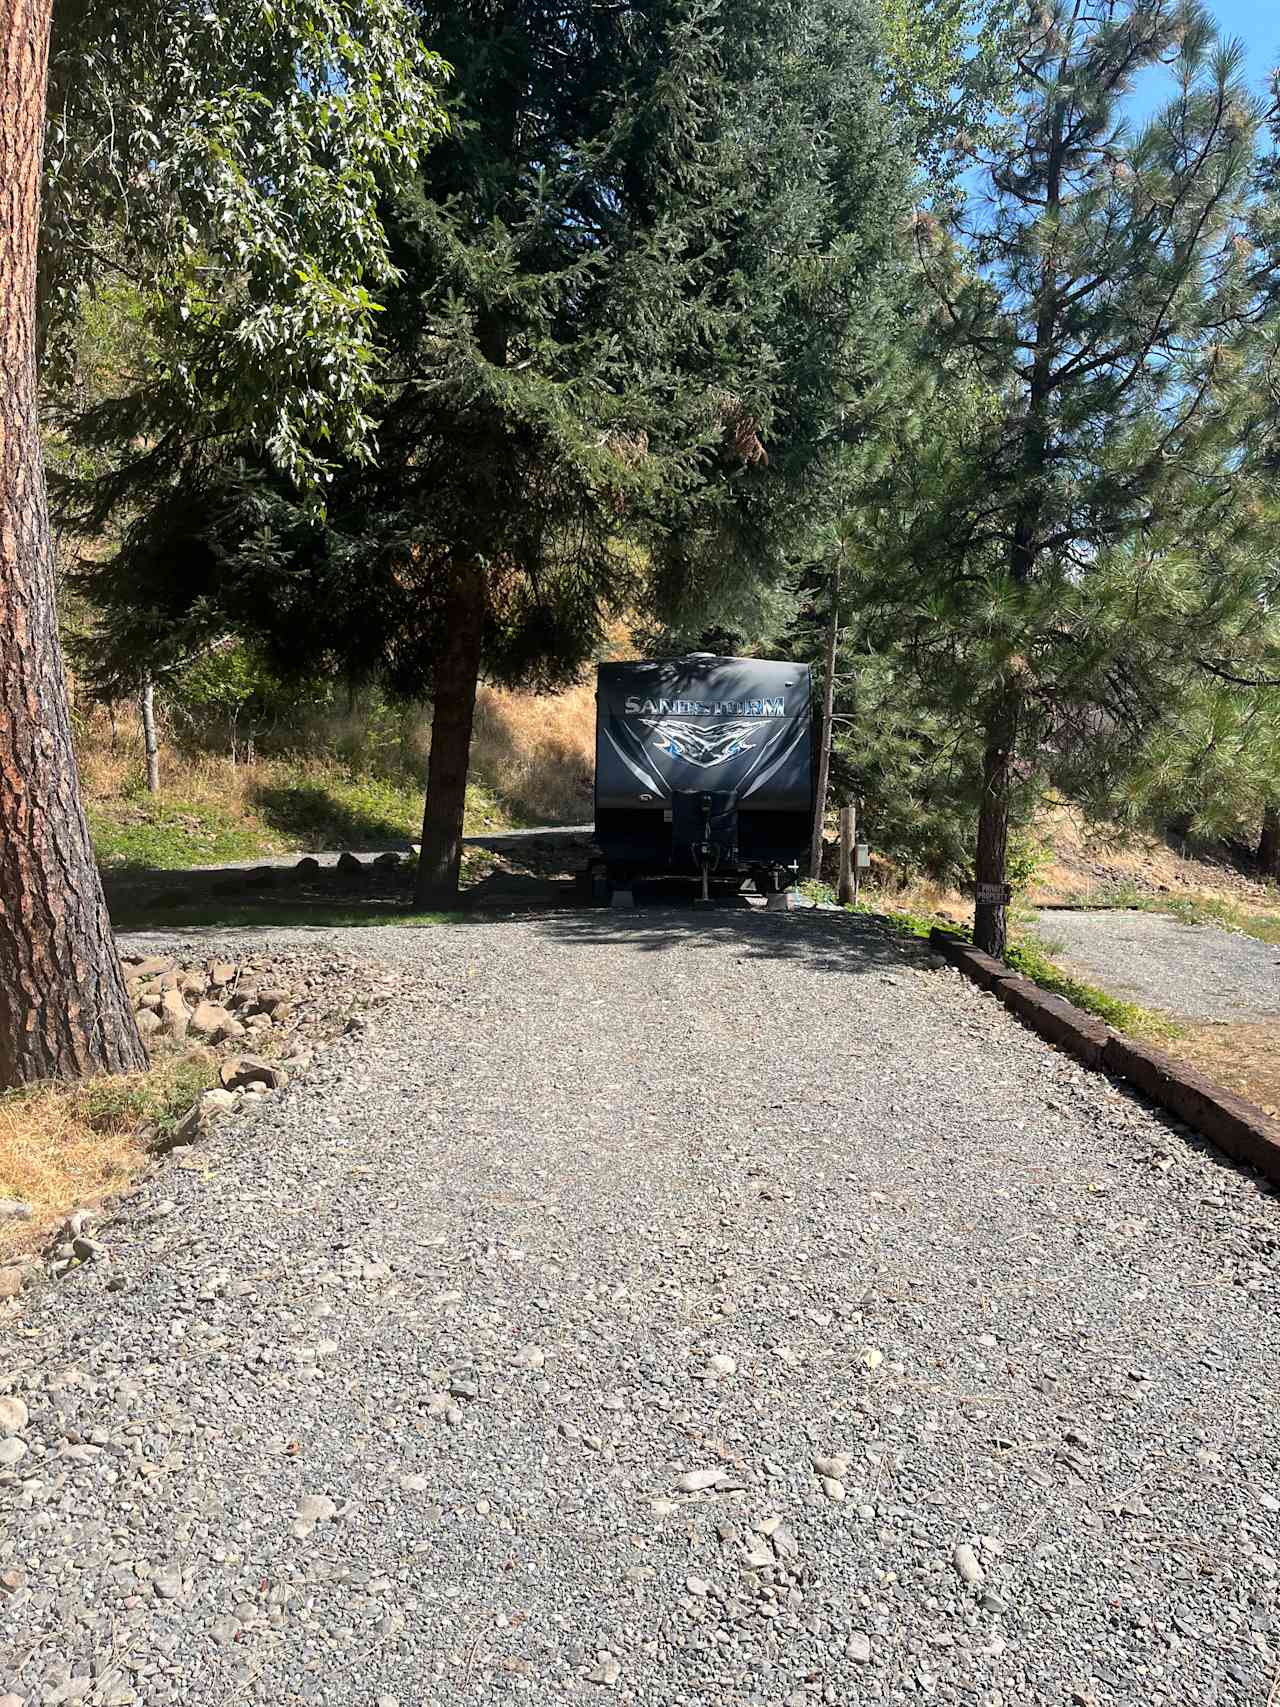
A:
[{"left": 872, "top": 0, "right": 1273, "bottom": 953}]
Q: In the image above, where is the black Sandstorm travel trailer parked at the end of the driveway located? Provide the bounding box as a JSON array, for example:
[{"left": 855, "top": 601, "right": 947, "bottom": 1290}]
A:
[{"left": 596, "top": 652, "right": 814, "bottom": 898}]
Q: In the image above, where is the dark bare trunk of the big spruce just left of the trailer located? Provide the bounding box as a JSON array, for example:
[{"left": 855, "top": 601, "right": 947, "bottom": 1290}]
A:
[{"left": 415, "top": 563, "right": 486, "bottom": 906}]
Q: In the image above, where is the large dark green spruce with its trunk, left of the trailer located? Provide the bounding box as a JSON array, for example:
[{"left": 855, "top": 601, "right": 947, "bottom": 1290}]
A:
[{"left": 67, "top": 0, "right": 906, "bottom": 905}]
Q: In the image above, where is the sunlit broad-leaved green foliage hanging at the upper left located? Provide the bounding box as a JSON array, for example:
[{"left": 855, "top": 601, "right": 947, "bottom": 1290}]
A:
[{"left": 41, "top": 0, "right": 444, "bottom": 478}]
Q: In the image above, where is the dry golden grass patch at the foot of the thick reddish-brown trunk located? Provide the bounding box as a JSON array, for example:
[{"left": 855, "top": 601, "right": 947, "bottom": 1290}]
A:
[{"left": 0, "top": 1050, "right": 217, "bottom": 1258}]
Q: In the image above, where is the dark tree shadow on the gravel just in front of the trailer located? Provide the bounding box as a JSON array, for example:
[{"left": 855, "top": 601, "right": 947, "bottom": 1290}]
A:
[{"left": 522, "top": 905, "right": 937, "bottom": 976}]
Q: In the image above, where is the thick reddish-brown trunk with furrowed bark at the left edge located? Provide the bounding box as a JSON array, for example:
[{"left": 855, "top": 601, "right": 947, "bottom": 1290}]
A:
[{"left": 0, "top": 0, "right": 147, "bottom": 1087}]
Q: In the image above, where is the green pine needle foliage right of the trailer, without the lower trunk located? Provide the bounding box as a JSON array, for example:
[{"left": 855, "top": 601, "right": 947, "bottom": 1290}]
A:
[{"left": 841, "top": 0, "right": 1280, "bottom": 908}]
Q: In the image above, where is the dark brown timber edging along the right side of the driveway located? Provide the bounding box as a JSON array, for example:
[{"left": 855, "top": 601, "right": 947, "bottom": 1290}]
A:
[{"left": 930, "top": 929, "right": 1280, "bottom": 1185}]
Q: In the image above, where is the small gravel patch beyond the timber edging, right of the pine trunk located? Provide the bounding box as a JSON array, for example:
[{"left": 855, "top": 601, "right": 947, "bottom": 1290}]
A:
[{"left": 1036, "top": 908, "right": 1280, "bottom": 1019}]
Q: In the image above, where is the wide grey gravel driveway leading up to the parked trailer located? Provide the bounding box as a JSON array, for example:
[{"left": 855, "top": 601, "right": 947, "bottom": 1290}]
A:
[{"left": 0, "top": 912, "right": 1280, "bottom": 1707}]
